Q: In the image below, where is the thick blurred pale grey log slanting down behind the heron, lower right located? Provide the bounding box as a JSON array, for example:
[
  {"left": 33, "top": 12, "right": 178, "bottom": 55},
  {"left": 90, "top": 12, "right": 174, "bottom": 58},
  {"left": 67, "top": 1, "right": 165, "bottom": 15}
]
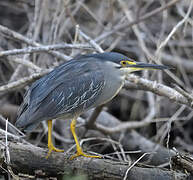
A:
[{"left": 91, "top": 111, "right": 175, "bottom": 165}]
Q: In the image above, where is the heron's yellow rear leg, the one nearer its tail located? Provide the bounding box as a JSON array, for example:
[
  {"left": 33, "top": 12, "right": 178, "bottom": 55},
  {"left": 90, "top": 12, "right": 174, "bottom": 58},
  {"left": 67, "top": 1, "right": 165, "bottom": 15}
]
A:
[{"left": 46, "top": 120, "right": 64, "bottom": 158}]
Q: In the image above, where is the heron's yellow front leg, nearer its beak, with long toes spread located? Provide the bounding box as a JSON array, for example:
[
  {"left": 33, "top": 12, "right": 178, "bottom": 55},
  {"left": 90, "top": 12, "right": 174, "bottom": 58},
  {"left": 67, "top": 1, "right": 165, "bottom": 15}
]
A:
[{"left": 70, "top": 119, "right": 101, "bottom": 160}]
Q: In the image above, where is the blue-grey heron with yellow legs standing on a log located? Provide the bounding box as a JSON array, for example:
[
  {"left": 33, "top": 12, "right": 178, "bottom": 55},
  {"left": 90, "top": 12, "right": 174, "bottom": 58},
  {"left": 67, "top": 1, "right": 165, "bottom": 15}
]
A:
[{"left": 16, "top": 52, "right": 169, "bottom": 159}]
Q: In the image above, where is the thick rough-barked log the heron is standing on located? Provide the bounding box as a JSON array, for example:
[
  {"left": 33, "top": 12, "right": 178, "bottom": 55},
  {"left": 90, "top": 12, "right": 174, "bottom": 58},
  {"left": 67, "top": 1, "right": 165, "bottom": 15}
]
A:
[{"left": 1, "top": 142, "right": 188, "bottom": 180}]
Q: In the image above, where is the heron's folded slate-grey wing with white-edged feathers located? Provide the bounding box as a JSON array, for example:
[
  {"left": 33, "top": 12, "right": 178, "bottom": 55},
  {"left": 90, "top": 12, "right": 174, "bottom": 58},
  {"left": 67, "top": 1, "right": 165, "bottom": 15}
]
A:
[{"left": 16, "top": 60, "right": 104, "bottom": 130}]
